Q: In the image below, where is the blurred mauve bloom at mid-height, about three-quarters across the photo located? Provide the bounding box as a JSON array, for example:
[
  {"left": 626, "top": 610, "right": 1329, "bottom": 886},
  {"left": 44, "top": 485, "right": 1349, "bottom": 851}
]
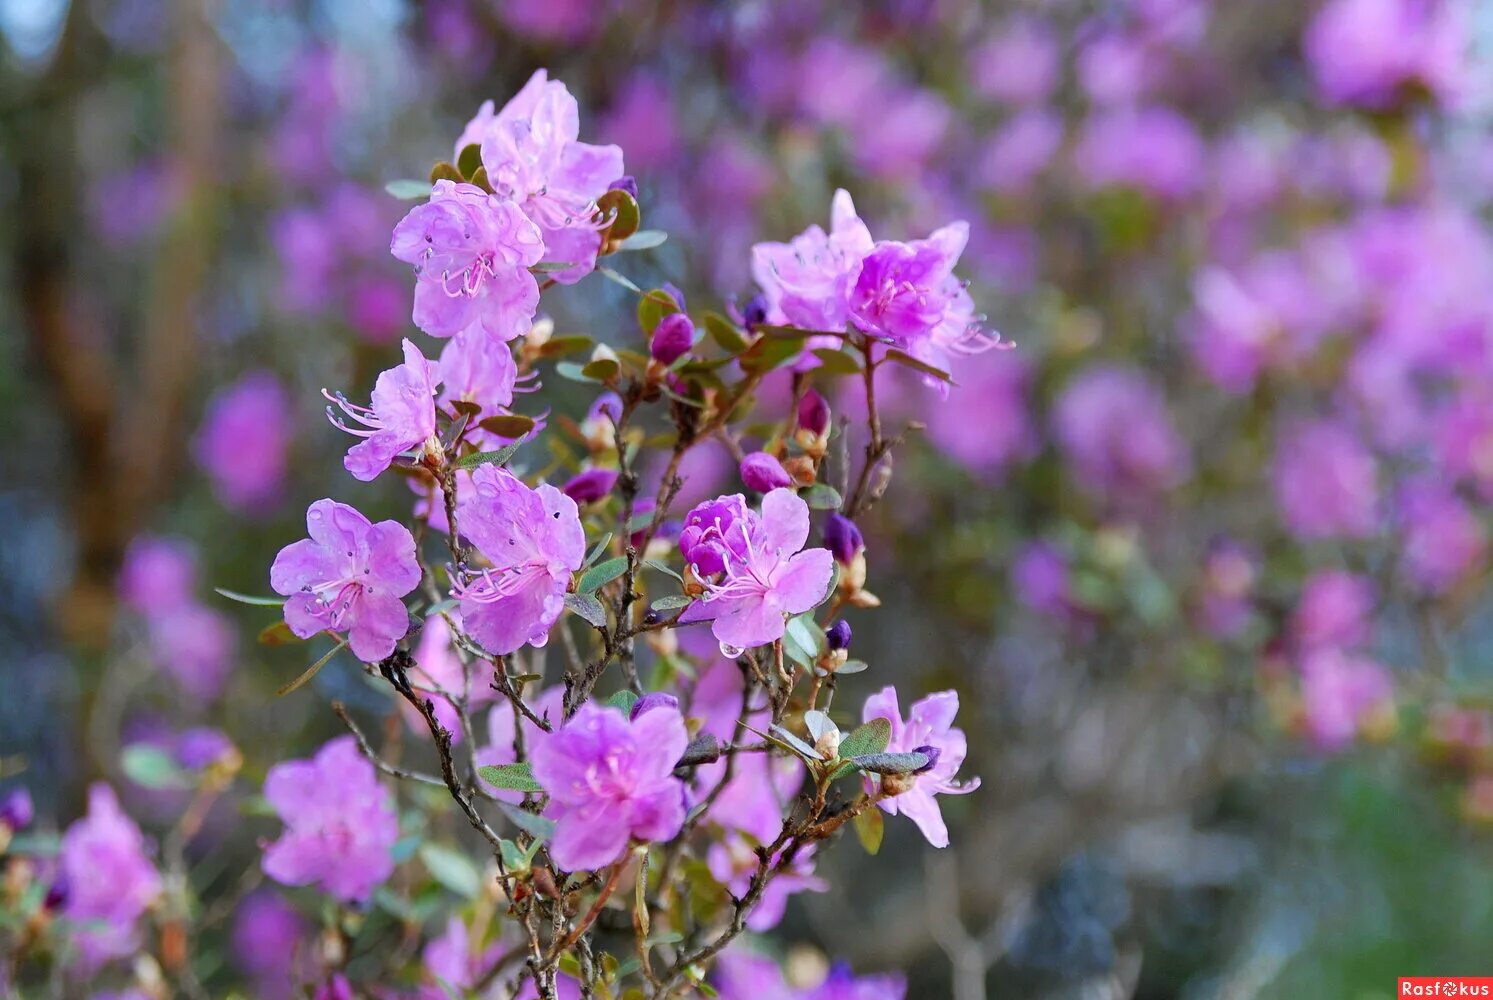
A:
[{"left": 1053, "top": 366, "right": 1188, "bottom": 500}]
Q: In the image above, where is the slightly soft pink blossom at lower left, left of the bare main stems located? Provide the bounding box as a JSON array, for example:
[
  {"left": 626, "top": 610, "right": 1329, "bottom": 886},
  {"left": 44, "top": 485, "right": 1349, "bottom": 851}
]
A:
[{"left": 264, "top": 736, "right": 399, "bottom": 901}]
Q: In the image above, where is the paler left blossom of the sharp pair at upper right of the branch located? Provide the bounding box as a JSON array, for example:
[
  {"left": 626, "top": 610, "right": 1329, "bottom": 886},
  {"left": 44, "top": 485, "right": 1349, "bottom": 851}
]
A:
[{"left": 751, "top": 191, "right": 872, "bottom": 337}]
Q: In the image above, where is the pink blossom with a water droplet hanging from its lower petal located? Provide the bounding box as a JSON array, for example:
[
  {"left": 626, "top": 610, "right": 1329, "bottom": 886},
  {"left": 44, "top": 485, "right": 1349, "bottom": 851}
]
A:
[{"left": 681, "top": 490, "right": 835, "bottom": 655}]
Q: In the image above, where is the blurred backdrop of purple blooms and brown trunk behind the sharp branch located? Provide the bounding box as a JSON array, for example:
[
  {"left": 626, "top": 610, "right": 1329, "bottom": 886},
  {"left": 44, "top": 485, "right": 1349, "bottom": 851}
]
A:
[{"left": 0, "top": 0, "right": 1493, "bottom": 1000}]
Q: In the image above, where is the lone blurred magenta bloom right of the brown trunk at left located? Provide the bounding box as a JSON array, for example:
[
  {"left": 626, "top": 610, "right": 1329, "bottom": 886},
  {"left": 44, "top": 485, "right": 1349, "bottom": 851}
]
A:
[{"left": 193, "top": 372, "right": 294, "bottom": 513}]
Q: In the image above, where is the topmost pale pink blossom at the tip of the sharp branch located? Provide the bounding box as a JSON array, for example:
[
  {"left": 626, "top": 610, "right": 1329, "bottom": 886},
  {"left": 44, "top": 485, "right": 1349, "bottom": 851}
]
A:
[{"left": 457, "top": 69, "right": 623, "bottom": 285}]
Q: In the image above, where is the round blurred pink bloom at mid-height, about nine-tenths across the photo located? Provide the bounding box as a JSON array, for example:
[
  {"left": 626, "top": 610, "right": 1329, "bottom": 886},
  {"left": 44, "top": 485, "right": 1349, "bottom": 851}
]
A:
[{"left": 1274, "top": 419, "right": 1380, "bottom": 539}]
